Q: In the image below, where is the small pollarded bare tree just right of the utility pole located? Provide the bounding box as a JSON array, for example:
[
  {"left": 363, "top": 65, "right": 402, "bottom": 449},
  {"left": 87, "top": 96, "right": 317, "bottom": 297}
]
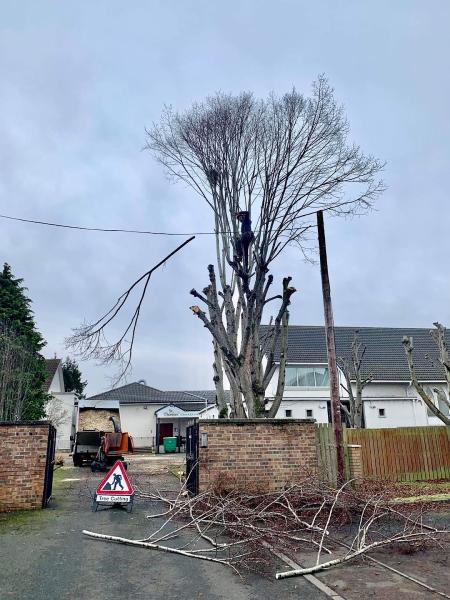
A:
[{"left": 338, "top": 330, "right": 374, "bottom": 427}]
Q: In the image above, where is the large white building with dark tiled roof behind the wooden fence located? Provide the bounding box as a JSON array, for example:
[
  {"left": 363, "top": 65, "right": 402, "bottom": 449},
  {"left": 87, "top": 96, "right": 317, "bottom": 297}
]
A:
[{"left": 267, "top": 326, "right": 450, "bottom": 428}]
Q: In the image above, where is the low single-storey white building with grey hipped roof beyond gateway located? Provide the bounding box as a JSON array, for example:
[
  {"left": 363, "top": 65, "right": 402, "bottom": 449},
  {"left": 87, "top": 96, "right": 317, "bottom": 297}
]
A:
[{"left": 87, "top": 382, "right": 218, "bottom": 450}]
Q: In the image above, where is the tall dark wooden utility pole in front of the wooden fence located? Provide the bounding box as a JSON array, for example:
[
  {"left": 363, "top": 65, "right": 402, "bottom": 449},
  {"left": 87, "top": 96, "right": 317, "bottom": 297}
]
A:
[{"left": 317, "top": 210, "right": 345, "bottom": 484}]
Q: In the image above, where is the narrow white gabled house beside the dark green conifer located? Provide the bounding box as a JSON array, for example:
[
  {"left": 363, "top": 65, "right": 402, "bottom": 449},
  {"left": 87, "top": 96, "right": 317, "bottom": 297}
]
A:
[{"left": 45, "top": 358, "right": 75, "bottom": 450}]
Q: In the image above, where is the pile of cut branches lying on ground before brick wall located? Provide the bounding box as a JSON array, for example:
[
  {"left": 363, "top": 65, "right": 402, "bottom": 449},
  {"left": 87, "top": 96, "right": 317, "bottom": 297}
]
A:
[{"left": 83, "top": 478, "right": 448, "bottom": 579}]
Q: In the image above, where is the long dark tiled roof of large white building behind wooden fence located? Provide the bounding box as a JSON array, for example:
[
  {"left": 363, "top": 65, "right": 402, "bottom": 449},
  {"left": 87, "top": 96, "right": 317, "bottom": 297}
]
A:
[{"left": 263, "top": 325, "right": 450, "bottom": 381}]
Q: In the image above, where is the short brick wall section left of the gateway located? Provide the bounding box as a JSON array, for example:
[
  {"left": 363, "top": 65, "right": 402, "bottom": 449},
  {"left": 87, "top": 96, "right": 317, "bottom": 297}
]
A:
[{"left": 0, "top": 422, "right": 49, "bottom": 512}]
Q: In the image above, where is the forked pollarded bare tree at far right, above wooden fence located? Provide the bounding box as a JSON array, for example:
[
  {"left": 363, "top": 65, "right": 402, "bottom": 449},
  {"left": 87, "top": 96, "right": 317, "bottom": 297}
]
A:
[{"left": 402, "top": 321, "right": 450, "bottom": 425}]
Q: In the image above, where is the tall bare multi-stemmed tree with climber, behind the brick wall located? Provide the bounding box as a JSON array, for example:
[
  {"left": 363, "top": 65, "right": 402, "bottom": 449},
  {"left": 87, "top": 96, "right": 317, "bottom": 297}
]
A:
[{"left": 148, "top": 77, "right": 383, "bottom": 417}]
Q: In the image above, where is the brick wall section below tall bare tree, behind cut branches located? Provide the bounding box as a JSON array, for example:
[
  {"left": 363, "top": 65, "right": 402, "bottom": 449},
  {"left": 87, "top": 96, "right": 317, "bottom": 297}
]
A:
[{"left": 199, "top": 419, "right": 318, "bottom": 491}]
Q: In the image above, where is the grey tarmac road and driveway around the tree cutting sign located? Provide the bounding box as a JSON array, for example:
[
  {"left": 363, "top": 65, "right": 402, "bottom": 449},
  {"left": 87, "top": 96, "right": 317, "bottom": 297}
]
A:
[{"left": 0, "top": 468, "right": 326, "bottom": 600}]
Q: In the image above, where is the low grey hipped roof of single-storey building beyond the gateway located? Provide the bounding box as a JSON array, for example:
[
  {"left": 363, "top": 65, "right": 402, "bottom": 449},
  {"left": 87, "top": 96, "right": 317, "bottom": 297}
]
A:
[{"left": 88, "top": 382, "right": 223, "bottom": 410}]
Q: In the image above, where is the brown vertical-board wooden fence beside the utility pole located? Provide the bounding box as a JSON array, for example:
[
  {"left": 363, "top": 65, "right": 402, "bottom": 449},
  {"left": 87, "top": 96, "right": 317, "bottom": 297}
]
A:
[{"left": 317, "top": 425, "right": 450, "bottom": 482}]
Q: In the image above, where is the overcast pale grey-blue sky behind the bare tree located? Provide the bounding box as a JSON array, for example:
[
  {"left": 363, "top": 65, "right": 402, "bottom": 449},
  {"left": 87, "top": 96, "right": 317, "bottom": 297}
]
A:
[{"left": 0, "top": 0, "right": 450, "bottom": 394}]
